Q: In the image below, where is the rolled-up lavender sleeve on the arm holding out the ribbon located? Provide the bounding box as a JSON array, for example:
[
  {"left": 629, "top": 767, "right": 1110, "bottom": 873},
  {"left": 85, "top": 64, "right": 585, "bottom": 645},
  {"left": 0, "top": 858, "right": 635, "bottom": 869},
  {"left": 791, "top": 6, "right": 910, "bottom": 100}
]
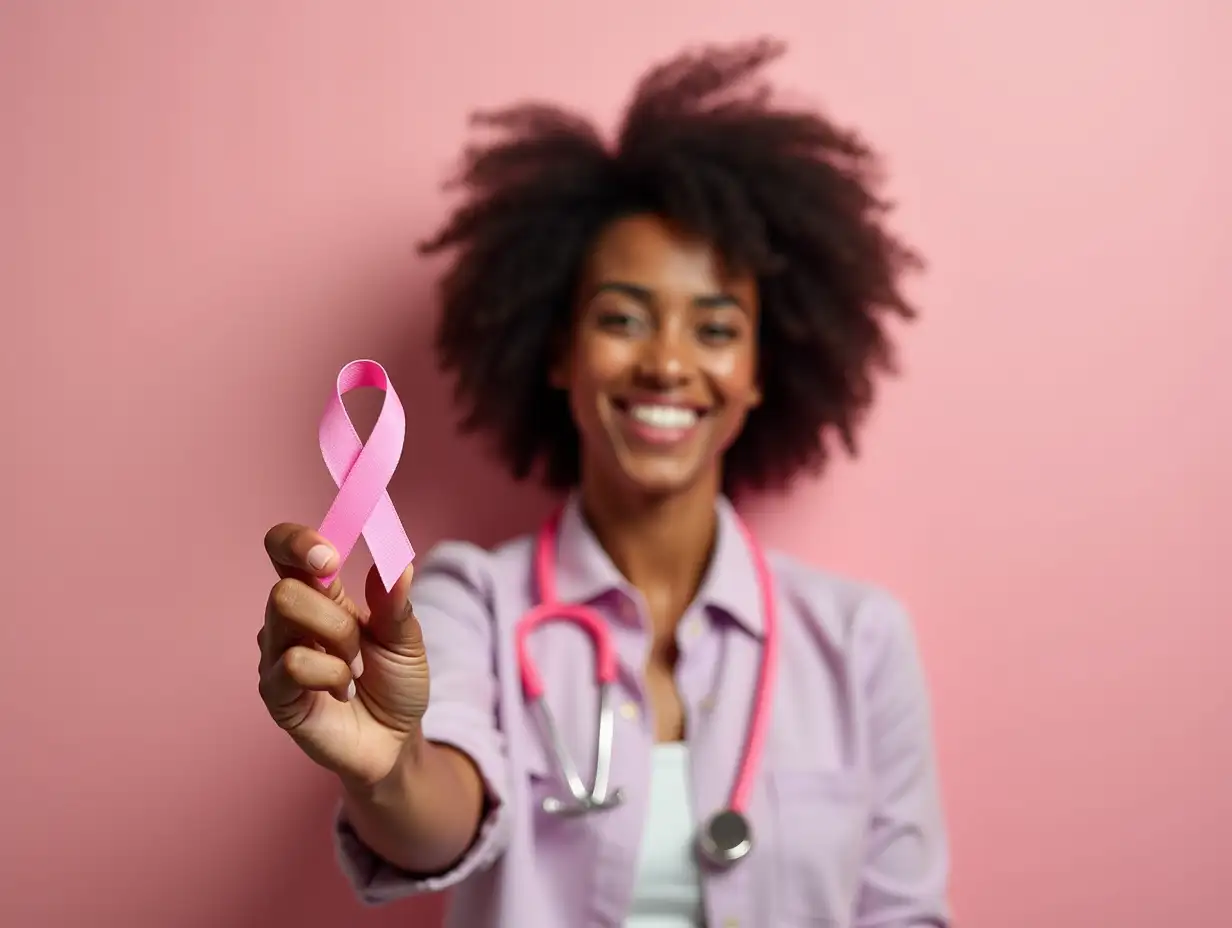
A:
[{"left": 334, "top": 534, "right": 509, "bottom": 906}]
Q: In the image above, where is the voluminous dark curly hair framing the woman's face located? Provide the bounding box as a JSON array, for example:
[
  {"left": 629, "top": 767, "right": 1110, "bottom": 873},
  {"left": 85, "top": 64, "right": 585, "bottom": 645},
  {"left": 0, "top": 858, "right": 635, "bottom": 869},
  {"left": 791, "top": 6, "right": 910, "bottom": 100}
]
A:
[{"left": 420, "top": 38, "right": 923, "bottom": 494}]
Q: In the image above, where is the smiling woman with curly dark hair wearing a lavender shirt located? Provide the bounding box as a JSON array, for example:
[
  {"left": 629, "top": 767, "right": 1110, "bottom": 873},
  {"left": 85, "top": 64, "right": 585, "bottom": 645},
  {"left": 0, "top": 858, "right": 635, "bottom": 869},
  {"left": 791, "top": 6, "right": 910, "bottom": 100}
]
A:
[{"left": 260, "top": 42, "right": 949, "bottom": 928}]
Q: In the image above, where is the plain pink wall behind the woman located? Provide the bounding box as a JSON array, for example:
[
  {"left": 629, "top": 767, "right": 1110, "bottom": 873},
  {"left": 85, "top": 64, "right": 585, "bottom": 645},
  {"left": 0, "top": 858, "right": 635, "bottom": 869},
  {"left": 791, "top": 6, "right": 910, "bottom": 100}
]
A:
[{"left": 0, "top": 0, "right": 1232, "bottom": 928}]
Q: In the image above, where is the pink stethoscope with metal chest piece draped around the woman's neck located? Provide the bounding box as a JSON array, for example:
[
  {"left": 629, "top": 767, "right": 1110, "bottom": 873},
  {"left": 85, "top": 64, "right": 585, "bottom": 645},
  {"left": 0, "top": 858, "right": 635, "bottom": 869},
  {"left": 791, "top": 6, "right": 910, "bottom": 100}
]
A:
[{"left": 516, "top": 502, "right": 777, "bottom": 868}]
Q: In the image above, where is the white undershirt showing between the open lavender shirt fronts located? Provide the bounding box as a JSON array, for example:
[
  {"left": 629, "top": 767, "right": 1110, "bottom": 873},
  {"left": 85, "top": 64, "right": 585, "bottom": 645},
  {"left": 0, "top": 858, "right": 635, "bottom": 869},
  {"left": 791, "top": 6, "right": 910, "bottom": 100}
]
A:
[{"left": 625, "top": 742, "right": 702, "bottom": 928}]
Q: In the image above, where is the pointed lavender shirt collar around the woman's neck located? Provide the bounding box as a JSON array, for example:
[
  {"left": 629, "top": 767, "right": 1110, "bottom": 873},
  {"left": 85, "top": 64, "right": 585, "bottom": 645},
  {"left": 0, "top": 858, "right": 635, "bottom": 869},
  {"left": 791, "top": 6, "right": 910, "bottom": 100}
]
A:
[{"left": 556, "top": 493, "right": 765, "bottom": 636}]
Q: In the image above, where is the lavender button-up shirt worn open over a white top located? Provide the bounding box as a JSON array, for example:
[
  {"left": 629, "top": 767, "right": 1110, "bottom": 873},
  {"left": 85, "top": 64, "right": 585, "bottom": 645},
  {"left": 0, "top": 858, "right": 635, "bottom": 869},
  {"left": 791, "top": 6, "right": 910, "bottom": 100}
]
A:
[{"left": 336, "top": 500, "right": 950, "bottom": 928}]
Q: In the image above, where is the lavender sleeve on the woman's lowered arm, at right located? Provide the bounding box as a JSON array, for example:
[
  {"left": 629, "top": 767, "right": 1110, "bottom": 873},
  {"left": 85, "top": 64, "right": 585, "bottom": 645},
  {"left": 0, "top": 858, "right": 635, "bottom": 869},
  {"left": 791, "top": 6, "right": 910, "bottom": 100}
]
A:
[{"left": 855, "top": 596, "right": 951, "bottom": 928}]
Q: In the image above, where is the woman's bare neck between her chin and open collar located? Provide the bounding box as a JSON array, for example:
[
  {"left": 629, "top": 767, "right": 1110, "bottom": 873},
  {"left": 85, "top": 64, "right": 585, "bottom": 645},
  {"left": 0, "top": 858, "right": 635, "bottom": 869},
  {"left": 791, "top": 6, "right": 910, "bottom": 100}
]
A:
[{"left": 582, "top": 474, "right": 718, "bottom": 611}]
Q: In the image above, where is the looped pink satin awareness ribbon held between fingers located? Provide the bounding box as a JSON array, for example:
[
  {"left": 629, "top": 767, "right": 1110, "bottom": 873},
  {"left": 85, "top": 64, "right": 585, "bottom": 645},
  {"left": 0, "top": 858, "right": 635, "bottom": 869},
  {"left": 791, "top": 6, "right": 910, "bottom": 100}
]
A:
[{"left": 319, "top": 361, "right": 415, "bottom": 593}]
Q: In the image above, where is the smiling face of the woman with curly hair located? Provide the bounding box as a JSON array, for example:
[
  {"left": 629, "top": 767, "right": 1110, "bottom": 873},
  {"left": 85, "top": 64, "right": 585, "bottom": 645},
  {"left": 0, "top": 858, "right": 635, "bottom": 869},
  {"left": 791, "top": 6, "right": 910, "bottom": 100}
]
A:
[{"left": 552, "top": 216, "right": 761, "bottom": 495}]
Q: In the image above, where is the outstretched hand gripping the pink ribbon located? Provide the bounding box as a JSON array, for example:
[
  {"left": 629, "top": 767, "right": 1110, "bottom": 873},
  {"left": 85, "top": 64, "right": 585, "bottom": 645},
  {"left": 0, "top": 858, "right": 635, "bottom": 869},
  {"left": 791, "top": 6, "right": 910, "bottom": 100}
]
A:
[{"left": 256, "top": 524, "right": 429, "bottom": 786}]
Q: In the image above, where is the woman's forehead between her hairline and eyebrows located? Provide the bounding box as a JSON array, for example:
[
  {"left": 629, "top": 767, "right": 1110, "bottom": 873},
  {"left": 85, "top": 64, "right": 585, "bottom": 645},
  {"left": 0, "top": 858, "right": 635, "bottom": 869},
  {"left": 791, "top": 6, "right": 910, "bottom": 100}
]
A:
[{"left": 585, "top": 214, "right": 747, "bottom": 292}]
